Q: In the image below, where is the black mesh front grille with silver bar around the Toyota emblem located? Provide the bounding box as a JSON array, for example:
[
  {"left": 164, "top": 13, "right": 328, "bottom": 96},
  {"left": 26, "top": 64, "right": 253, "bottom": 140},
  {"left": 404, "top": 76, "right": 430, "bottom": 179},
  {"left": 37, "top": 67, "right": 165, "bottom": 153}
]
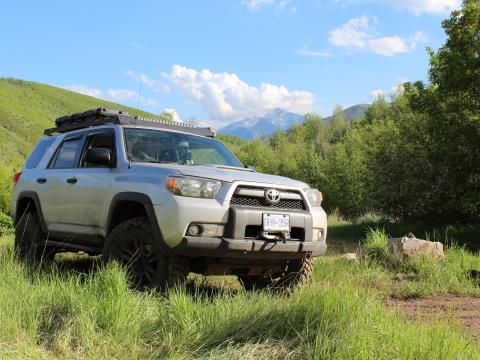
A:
[{"left": 230, "top": 186, "right": 306, "bottom": 210}]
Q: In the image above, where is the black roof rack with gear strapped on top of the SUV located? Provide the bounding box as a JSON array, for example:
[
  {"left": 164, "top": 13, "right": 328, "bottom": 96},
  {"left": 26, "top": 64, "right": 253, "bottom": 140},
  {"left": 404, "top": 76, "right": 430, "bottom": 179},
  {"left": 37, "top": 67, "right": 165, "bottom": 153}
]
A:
[{"left": 44, "top": 108, "right": 215, "bottom": 138}]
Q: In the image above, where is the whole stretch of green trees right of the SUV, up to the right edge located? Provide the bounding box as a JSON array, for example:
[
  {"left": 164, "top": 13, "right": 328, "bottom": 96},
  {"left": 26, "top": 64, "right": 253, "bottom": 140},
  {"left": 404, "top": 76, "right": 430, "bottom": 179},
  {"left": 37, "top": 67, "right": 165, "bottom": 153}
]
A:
[{"left": 224, "top": 0, "right": 480, "bottom": 223}]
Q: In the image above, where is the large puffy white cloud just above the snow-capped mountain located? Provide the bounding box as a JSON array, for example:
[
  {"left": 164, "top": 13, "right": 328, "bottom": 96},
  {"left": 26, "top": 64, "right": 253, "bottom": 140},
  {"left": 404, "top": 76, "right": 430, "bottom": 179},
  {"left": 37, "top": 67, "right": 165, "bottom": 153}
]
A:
[{"left": 164, "top": 65, "right": 315, "bottom": 121}]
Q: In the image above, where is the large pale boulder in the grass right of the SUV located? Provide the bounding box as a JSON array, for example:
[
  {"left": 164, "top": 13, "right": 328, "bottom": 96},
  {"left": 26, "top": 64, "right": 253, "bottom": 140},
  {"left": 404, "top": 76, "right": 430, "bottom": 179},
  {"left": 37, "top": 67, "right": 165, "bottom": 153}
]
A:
[{"left": 388, "top": 237, "right": 445, "bottom": 260}]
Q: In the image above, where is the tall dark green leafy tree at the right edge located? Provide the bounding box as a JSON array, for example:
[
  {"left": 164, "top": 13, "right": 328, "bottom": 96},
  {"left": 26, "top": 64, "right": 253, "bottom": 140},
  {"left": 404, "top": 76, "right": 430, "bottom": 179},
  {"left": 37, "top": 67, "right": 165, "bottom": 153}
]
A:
[{"left": 406, "top": 0, "right": 480, "bottom": 222}]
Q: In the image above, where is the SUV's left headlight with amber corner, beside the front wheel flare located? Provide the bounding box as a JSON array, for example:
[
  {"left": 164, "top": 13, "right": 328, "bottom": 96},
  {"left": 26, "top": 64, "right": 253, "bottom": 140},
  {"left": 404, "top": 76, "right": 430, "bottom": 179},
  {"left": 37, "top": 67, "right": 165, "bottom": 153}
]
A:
[{"left": 165, "top": 176, "right": 222, "bottom": 199}]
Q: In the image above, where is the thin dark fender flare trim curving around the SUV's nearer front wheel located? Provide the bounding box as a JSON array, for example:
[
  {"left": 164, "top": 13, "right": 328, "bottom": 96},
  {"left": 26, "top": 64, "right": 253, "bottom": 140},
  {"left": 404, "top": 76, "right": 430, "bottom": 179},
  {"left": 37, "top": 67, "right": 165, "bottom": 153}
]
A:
[{"left": 106, "top": 191, "right": 171, "bottom": 255}]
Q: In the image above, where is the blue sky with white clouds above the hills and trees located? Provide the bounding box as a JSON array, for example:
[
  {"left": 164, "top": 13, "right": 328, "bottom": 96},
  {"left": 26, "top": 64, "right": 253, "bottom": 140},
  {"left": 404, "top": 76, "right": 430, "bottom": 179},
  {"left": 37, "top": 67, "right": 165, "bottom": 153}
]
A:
[{"left": 0, "top": 0, "right": 459, "bottom": 127}]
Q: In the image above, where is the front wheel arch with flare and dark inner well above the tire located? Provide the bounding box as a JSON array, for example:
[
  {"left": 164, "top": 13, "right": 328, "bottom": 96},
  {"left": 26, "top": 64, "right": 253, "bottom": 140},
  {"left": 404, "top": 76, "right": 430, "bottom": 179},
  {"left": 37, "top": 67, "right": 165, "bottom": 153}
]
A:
[{"left": 106, "top": 191, "right": 170, "bottom": 255}]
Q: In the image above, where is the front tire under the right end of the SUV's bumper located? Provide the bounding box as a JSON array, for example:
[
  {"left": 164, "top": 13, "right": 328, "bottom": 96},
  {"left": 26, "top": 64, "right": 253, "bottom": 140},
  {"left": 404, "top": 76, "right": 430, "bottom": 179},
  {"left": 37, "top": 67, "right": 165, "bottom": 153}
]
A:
[{"left": 238, "top": 257, "right": 313, "bottom": 292}]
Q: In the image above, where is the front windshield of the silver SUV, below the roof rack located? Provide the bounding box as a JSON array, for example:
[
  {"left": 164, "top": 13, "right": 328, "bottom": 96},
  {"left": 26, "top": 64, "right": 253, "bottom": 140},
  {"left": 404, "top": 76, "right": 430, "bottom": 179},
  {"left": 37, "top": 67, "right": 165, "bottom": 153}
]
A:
[{"left": 125, "top": 128, "right": 243, "bottom": 167}]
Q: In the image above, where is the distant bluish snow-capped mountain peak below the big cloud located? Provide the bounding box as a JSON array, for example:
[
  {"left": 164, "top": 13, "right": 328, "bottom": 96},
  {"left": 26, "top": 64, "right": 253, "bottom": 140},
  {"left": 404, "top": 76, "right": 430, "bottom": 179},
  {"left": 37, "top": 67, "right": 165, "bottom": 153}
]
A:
[{"left": 218, "top": 109, "right": 304, "bottom": 140}]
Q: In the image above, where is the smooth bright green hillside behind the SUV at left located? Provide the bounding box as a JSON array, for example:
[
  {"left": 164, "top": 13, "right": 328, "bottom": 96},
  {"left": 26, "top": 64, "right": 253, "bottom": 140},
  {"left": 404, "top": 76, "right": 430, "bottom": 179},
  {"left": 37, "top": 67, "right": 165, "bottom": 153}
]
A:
[{"left": 0, "top": 78, "right": 169, "bottom": 212}]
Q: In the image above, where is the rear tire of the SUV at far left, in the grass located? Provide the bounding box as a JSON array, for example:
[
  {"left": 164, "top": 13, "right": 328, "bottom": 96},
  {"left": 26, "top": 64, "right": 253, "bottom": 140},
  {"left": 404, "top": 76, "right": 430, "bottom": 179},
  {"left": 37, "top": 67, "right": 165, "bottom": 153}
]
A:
[{"left": 14, "top": 212, "right": 55, "bottom": 263}]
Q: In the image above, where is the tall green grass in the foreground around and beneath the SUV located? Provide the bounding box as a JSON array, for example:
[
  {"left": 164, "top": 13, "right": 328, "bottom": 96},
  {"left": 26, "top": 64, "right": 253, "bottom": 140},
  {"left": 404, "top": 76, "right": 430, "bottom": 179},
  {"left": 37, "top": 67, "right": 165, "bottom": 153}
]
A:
[{"left": 0, "top": 225, "right": 480, "bottom": 359}]
